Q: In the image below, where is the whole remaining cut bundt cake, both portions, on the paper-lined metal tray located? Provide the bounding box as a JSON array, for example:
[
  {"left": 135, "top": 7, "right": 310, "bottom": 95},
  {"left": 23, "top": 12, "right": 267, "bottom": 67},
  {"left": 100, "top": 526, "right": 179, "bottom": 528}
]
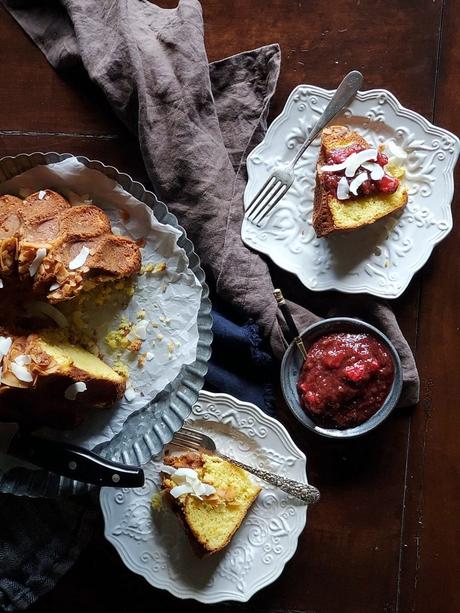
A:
[{"left": 0, "top": 189, "right": 141, "bottom": 427}]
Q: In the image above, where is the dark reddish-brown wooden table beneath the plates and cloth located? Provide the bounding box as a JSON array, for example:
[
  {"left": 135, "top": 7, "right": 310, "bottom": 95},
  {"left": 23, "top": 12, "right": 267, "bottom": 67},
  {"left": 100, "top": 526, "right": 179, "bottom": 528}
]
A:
[{"left": 0, "top": 0, "right": 460, "bottom": 613}]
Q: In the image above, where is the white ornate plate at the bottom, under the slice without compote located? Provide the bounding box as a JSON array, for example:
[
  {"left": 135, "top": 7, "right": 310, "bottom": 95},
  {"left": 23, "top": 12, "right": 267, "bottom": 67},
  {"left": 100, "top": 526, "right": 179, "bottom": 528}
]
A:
[{"left": 100, "top": 391, "right": 307, "bottom": 603}]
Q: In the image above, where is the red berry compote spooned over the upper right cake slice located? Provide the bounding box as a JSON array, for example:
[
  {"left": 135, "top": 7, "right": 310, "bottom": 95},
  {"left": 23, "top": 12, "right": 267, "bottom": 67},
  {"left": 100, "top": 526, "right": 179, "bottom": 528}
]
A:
[{"left": 323, "top": 143, "right": 399, "bottom": 198}]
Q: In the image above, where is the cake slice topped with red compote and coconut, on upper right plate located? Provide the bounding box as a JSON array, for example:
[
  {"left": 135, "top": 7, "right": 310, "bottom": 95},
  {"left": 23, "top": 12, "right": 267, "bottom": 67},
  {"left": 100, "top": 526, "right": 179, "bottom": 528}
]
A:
[{"left": 313, "top": 126, "right": 407, "bottom": 236}]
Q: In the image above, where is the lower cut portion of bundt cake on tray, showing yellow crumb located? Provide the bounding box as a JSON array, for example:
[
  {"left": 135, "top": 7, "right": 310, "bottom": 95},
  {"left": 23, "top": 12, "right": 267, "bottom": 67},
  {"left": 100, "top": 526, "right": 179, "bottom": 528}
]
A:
[{"left": 0, "top": 328, "right": 126, "bottom": 427}]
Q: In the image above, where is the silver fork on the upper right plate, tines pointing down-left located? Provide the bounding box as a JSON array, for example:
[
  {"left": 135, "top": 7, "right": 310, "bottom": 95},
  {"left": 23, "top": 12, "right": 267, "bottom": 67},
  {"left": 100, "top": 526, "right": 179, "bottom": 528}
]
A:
[{"left": 246, "top": 70, "right": 363, "bottom": 226}]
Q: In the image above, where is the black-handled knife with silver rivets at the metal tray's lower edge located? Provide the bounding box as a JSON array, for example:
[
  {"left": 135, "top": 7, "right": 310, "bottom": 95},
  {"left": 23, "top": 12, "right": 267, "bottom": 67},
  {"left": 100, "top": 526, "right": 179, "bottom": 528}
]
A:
[{"left": 0, "top": 423, "right": 144, "bottom": 487}]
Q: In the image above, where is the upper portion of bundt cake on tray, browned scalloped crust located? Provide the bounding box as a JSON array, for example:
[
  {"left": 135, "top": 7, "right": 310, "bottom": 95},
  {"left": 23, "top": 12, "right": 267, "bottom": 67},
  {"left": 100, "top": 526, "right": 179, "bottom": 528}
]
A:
[{"left": 0, "top": 189, "right": 141, "bottom": 303}]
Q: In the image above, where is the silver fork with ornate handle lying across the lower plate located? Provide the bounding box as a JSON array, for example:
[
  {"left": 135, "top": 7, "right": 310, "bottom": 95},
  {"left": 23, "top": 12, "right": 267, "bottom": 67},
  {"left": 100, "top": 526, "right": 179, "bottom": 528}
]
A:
[{"left": 170, "top": 427, "right": 320, "bottom": 504}]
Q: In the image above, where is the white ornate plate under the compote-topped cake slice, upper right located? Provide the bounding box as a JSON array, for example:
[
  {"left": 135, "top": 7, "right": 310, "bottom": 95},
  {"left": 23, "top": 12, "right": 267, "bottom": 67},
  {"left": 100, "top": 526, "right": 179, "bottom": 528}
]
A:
[{"left": 241, "top": 85, "right": 459, "bottom": 298}]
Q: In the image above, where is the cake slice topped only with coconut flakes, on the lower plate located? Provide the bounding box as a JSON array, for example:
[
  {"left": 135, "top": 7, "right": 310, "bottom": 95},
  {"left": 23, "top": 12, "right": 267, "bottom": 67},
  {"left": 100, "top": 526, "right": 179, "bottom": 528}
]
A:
[{"left": 161, "top": 453, "right": 261, "bottom": 556}]
